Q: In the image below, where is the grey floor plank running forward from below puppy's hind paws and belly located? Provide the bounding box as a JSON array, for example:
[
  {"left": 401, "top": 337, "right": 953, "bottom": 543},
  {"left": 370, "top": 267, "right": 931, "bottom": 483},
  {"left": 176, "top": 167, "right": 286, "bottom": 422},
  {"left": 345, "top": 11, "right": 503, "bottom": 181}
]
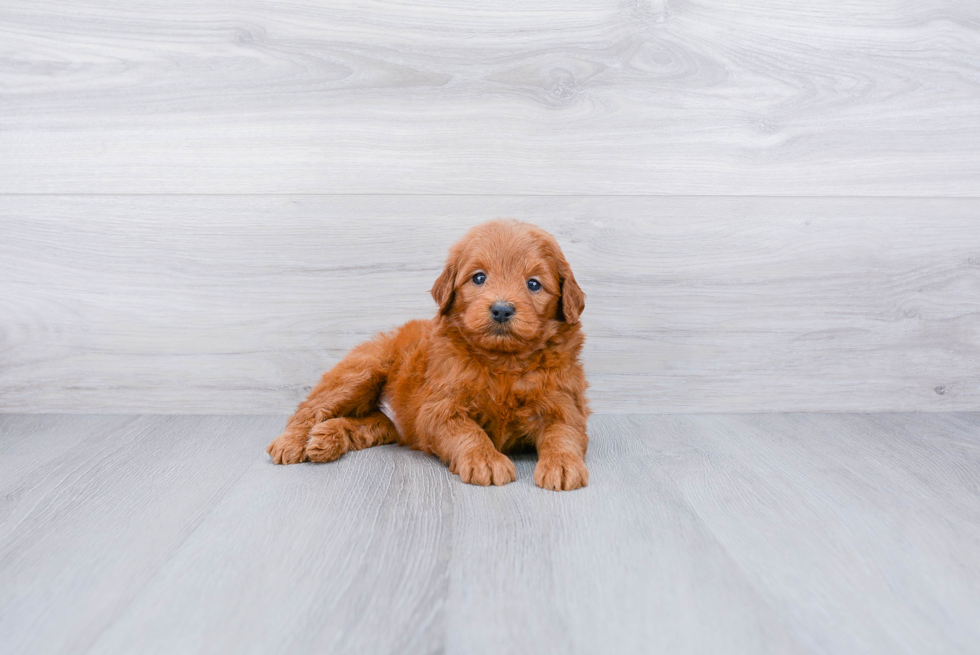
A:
[{"left": 90, "top": 428, "right": 461, "bottom": 655}]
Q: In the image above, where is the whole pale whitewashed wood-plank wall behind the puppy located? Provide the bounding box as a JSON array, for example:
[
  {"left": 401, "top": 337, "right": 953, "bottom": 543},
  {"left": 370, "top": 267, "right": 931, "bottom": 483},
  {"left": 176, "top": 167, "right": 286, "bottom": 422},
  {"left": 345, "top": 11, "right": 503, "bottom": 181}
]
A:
[{"left": 0, "top": 0, "right": 980, "bottom": 413}]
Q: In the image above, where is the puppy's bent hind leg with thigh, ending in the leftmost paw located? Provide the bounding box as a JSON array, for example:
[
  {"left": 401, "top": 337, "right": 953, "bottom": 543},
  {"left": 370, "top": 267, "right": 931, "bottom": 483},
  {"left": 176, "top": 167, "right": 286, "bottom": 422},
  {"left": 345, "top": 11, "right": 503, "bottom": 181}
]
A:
[{"left": 266, "top": 337, "right": 391, "bottom": 464}]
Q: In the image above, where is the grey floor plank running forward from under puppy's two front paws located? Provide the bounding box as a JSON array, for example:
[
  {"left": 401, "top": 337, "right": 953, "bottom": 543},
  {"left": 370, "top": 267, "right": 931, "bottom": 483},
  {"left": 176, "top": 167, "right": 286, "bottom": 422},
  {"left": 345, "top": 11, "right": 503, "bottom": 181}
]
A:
[{"left": 446, "top": 416, "right": 810, "bottom": 655}]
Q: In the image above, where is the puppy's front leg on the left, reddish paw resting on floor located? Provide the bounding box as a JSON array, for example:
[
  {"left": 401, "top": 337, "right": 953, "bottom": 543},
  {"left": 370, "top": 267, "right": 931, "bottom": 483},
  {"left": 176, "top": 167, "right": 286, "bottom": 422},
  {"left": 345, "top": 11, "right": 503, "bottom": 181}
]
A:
[{"left": 427, "top": 417, "right": 517, "bottom": 487}]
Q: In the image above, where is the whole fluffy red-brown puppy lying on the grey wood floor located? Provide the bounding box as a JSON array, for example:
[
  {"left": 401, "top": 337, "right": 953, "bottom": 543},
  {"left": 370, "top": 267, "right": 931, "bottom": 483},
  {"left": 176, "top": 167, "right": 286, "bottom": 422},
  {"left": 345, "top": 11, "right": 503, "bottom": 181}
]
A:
[{"left": 267, "top": 220, "right": 590, "bottom": 490}]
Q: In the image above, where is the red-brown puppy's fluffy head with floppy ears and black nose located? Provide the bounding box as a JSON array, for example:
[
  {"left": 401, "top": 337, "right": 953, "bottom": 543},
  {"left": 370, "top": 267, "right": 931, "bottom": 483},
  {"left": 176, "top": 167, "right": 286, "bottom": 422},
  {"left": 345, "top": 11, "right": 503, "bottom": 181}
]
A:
[{"left": 432, "top": 220, "right": 585, "bottom": 352}]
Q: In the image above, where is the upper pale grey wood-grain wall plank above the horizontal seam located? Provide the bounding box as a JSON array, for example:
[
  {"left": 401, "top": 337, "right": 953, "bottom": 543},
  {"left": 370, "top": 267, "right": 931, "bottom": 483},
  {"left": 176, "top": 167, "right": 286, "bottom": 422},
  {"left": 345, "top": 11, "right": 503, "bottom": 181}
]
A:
[{"left": 0, "top": 0, "right": 980, "bottom": 196}]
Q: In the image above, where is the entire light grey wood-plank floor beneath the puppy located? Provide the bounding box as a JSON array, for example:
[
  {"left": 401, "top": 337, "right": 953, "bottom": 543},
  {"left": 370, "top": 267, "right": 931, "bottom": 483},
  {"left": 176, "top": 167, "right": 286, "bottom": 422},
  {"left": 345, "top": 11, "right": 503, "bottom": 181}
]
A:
[{"left": 0, "top": 414, "right": 980, "bottom": 654}]
